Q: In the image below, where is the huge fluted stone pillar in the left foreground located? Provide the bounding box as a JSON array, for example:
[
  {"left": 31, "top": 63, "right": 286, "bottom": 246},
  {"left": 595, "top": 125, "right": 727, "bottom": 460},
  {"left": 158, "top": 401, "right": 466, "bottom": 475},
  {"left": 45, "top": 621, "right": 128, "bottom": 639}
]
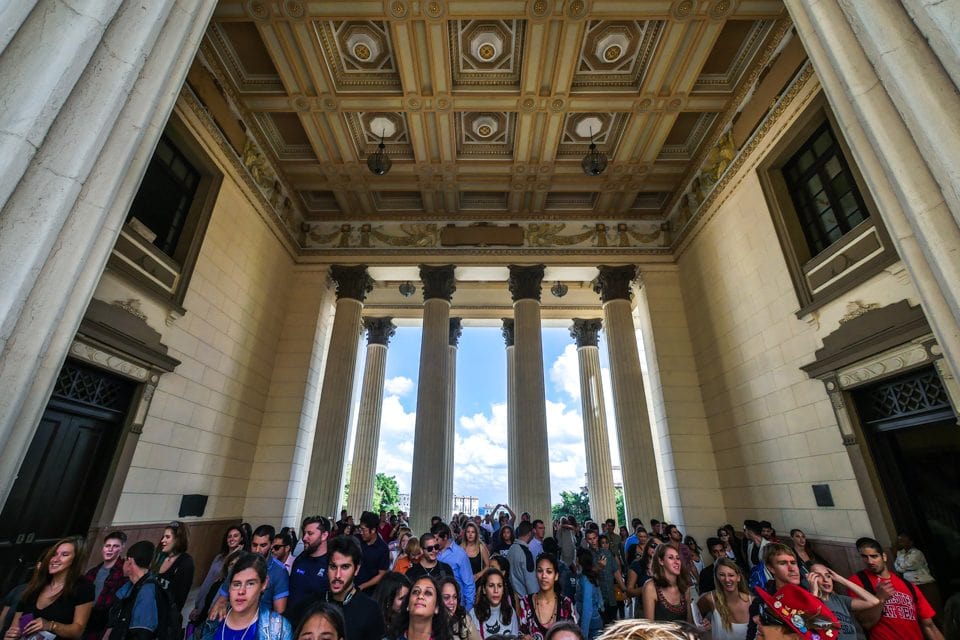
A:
[{"left": 0, "top": 0, "right": 216, "bottom": 510}]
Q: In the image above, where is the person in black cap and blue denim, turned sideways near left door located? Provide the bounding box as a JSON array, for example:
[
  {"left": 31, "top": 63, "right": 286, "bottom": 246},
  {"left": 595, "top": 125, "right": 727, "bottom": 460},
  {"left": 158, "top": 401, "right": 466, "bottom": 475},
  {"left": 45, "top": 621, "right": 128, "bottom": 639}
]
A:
[{"left": 110, "top": 540, "right": 160, "bottom": 640}]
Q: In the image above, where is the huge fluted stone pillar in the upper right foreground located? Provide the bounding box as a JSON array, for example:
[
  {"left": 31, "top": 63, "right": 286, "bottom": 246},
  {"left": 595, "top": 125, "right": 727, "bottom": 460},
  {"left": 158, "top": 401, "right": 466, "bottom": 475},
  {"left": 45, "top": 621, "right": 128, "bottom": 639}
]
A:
[{"left": 784, "top": 0, "right": 960, "bottom": 376}]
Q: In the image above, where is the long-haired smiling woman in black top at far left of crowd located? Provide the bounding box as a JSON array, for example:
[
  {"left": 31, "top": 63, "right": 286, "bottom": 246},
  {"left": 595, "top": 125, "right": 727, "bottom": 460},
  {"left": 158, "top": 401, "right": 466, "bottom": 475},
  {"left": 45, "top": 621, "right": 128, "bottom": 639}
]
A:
[{"left": 5, "top": 538, "right": 94, "bottom": 640}]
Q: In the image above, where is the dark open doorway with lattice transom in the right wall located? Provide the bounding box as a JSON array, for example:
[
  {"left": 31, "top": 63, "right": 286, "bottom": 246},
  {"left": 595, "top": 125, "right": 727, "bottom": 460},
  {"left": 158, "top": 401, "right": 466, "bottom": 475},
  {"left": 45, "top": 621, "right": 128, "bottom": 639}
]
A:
[{"left": 856, "top": 368, "right": 960, "bottom": 596}]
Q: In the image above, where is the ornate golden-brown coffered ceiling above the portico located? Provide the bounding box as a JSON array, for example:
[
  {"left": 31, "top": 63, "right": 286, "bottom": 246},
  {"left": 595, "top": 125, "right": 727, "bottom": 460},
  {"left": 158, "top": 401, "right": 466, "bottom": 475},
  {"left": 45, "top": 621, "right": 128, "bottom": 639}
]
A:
[{"left": 201, "top": 0, "right": 789, "bottom": 251}]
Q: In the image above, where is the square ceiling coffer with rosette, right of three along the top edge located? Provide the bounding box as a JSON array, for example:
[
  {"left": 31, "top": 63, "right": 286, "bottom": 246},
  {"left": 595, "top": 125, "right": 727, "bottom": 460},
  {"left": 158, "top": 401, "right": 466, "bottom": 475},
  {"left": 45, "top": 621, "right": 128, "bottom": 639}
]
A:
[{"left": 572, "top": 20, "right": 664, "bottom": 92}]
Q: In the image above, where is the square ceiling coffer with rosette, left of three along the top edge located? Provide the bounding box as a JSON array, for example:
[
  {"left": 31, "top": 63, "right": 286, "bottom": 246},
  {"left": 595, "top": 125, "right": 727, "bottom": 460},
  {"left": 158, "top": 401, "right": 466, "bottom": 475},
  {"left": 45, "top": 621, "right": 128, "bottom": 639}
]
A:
[{"left": 313, "top": 20, "right": 400, "bottom": 93}]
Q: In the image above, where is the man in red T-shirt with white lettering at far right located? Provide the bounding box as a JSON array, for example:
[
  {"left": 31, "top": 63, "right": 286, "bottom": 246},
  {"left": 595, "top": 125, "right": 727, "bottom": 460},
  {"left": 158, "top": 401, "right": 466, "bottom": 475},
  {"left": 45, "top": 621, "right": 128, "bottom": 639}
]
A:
[{"left": 850, "top": 538, "right": 943, "bottom": 640}]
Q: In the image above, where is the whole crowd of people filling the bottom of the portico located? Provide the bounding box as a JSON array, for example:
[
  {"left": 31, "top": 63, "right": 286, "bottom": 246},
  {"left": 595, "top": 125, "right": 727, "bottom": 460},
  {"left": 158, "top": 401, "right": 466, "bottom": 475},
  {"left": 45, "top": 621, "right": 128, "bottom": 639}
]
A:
[{"left": 2, "top": 505, "right": 960, "bottom": 640}]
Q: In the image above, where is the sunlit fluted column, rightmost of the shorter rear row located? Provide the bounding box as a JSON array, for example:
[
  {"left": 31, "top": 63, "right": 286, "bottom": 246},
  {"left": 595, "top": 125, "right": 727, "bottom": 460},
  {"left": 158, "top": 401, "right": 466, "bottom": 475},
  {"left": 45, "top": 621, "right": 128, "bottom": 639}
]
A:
[{"left": 570, "top": 318, "right": 617, "bottom": 522}]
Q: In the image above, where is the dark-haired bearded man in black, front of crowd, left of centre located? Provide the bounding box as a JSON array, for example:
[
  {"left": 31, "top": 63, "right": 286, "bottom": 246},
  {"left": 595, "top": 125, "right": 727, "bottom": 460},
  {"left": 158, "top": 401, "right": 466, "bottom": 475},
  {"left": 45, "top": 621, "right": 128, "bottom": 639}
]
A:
[{"left": 326, "top": 536, "right": 385, "bottom": 640}]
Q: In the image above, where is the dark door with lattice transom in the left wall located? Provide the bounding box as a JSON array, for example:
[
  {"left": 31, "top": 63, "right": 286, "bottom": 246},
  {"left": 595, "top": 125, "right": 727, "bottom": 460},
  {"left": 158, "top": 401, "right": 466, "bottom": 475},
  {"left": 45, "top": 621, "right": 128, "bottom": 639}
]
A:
[{"left": 0, "top": 360, "right": 135, "bottom": 592}]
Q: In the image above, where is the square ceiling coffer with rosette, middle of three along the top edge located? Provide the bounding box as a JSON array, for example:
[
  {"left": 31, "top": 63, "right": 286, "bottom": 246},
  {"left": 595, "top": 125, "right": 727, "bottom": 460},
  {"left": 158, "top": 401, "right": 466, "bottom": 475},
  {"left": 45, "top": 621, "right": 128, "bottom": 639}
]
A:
[{"left": 449, "top": 20, "right": 526, "bottom": 90}]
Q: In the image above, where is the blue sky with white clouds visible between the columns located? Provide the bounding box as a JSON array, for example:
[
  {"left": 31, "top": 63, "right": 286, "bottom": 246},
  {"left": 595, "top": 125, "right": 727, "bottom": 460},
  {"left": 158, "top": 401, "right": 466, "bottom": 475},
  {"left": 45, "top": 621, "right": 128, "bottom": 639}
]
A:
[{"left": 348, "top": 327, "right": 619, "bottom": 506}]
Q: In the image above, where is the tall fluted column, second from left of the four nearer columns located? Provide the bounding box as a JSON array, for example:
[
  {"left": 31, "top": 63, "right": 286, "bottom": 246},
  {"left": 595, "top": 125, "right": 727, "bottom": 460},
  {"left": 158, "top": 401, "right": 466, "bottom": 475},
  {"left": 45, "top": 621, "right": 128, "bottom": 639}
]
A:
[{"left": 410, "top": 264, "right": 457, "bottom": 533}]
